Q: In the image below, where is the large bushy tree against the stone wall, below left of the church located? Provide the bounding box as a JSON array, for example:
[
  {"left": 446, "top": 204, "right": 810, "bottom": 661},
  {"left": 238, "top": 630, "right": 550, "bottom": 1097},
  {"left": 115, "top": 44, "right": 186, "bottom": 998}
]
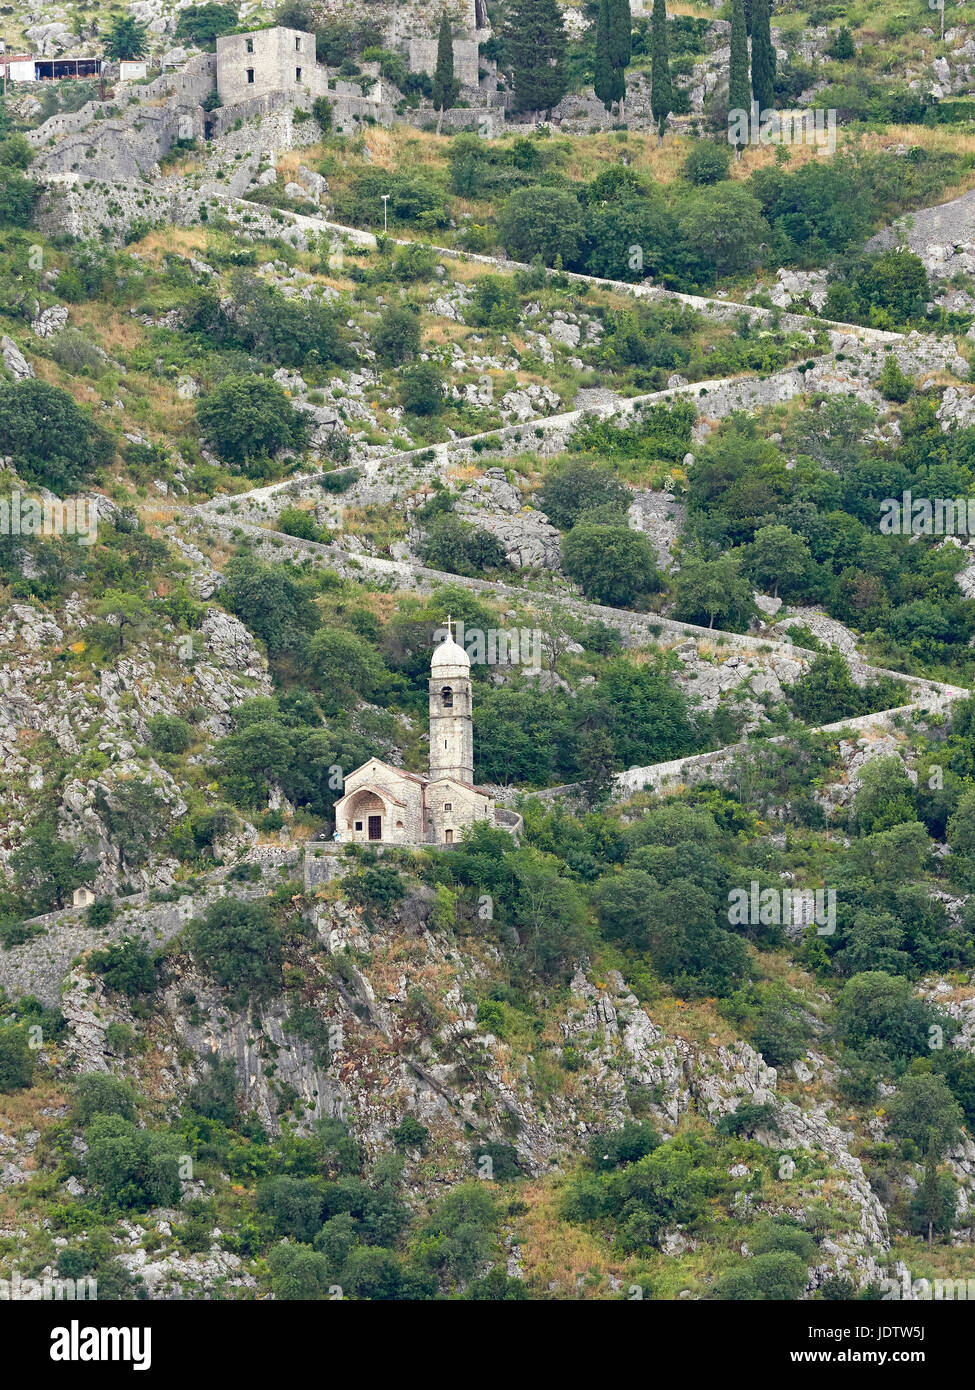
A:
[{"left": 188, "top": 898, "right": 284, "bottom": 1006}]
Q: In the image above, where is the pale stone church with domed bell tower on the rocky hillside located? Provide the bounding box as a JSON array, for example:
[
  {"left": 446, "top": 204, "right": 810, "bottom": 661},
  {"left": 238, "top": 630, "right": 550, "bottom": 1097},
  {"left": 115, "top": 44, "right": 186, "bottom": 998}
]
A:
[{"left": 335, "top": 631, "right": 509, "bottom": 845}]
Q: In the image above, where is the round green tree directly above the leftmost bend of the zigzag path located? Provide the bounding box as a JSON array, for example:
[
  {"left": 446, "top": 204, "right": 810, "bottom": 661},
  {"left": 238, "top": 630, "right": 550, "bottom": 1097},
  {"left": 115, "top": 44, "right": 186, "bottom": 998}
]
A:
[{"left": 196, "top": 377, "right": 309, "bottom": 464}]
